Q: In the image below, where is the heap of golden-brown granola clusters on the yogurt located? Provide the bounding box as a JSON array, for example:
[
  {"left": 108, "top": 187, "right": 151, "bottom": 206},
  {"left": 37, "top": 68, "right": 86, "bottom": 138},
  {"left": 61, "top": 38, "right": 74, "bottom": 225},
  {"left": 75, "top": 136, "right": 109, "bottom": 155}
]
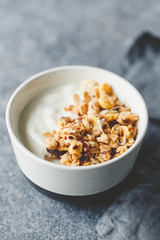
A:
[{"left": 44, "top": 80, "right": 139, "bottom": 166}]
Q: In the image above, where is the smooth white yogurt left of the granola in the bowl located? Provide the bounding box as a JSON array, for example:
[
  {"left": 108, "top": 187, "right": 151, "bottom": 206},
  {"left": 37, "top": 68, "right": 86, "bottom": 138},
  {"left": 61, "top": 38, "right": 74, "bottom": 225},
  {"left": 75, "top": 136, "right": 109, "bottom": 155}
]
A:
[{"left": 19, "top": 83, "right": 80, "bottom": 157}]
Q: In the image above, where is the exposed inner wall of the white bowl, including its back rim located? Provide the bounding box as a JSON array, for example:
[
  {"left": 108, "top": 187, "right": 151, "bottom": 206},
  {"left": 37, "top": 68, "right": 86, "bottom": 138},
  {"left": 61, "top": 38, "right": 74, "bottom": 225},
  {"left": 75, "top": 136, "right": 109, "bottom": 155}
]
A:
[{"left": 9, "top": 66, "right": 148, "bottom": 162}]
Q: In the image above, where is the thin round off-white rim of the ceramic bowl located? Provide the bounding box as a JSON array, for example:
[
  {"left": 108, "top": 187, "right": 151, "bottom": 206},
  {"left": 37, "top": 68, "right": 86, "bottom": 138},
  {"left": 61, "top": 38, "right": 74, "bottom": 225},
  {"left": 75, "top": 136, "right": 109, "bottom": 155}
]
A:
[{"left": 6, "top": 65, "right": 148, "bottom": 171}]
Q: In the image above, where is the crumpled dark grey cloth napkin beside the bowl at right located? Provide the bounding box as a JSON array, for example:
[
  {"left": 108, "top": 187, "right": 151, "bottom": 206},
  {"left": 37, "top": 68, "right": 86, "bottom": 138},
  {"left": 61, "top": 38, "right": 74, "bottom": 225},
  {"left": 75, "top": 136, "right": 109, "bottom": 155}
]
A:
[{"left": 96, "top": 33, "right": 160, "bottom": 240}]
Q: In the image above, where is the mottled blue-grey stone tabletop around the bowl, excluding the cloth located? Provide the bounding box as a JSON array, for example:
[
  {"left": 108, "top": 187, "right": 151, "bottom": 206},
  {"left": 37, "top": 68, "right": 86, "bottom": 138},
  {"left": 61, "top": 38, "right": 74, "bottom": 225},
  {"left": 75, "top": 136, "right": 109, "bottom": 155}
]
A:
[{"left": 0, "top": 0, "right": 160, "bottom": 240}]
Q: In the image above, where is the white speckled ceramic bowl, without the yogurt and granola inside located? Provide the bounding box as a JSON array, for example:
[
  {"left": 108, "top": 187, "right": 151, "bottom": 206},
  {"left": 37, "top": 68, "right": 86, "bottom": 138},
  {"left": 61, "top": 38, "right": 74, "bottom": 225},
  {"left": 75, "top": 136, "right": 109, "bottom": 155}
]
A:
[{"left": 6, "top": 66, "right": 148, "bottom": 196}]
